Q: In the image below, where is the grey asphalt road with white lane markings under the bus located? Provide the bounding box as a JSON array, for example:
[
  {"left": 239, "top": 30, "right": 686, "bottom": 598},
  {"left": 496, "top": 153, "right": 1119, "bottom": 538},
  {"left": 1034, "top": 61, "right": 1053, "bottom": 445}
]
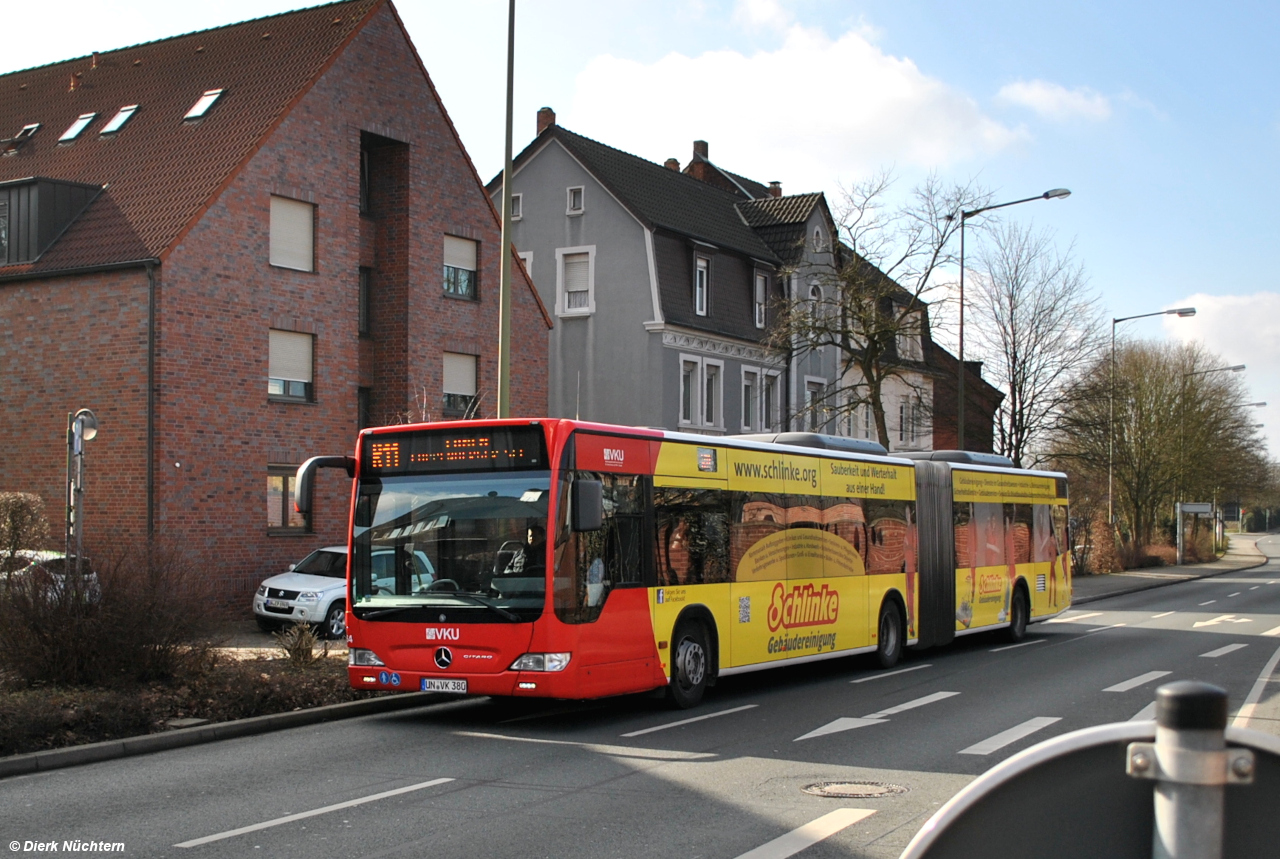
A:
[{"left": 0, "top": 538, "right": 1280, "bottom": 859}]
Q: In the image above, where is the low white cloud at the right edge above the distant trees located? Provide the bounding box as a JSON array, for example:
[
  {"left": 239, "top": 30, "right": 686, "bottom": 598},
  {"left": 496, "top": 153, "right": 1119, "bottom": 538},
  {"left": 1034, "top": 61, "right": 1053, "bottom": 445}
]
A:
[{"left": 1164, "top": 292, "right": 1280, "bottom": 456}]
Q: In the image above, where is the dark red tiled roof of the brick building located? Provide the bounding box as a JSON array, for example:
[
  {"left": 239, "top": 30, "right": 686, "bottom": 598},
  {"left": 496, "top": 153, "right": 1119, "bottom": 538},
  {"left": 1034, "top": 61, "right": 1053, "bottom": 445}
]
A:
[{"left": 0, "top": 0, "right": 385, "bottom": 277}]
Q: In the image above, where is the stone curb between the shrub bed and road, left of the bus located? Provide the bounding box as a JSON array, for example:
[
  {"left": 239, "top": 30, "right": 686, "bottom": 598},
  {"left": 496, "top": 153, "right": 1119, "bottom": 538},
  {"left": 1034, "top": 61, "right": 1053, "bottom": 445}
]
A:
[{"left": 0, "top": 693, "right": 445, "bottom": 778}]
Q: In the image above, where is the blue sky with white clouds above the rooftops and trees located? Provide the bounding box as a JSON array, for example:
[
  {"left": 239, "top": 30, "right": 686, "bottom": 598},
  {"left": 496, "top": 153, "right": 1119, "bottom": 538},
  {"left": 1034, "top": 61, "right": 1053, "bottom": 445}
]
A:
[{"left": 10, "top": 0, "right": 1280, "bottom": 451}]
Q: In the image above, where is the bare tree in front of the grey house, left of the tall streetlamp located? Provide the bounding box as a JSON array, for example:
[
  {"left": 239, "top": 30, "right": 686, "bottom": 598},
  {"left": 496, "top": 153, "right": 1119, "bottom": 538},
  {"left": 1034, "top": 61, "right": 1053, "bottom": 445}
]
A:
[{"left": 768, "top": 172, "right": 989, "bottom": 447}]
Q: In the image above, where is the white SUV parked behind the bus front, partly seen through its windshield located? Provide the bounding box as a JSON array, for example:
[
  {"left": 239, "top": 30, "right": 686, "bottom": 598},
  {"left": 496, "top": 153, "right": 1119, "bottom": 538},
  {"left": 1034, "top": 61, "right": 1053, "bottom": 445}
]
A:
[{"left": 253, "top": 545, "right": 435, "bottom": 639}]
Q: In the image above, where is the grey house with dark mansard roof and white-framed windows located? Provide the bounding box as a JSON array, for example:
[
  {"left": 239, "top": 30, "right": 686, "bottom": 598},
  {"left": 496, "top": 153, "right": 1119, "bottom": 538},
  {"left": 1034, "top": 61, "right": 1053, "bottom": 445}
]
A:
[{"left": 488, "top": 108, "right": 977, "bottom": 451}]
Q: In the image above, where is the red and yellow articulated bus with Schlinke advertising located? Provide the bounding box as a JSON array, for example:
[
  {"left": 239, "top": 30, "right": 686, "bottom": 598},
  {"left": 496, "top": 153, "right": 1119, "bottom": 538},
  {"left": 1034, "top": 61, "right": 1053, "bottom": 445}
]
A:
[{"left": 296, "top": 419, "right": 1071, "bottom": 707}]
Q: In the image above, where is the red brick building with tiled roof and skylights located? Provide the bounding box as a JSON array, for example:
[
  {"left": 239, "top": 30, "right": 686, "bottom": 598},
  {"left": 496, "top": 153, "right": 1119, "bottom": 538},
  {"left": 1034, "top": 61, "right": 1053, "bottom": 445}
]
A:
[{"left": 0, "top": 0, "right": 552, "bottom": 598}]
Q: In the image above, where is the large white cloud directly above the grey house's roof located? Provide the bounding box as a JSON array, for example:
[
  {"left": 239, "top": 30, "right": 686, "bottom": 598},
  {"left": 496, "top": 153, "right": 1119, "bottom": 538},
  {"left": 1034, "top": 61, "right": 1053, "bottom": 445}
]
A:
[{"left": 562, "top": 23, "right": 1025, "bottom": 192}]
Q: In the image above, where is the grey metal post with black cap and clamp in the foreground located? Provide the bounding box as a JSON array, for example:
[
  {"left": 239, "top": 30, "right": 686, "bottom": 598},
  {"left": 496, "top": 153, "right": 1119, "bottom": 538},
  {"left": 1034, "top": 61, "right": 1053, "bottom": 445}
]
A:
[{"left": 1126, "top": 680, "right": 1253, "bottom": 859}]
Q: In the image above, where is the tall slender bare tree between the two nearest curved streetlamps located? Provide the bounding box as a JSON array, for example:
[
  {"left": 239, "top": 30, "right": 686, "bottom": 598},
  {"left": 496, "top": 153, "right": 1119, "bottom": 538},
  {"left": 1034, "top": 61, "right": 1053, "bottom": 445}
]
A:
[{"left": 970, "top": 223, "right": 1103, "bottom": 466}]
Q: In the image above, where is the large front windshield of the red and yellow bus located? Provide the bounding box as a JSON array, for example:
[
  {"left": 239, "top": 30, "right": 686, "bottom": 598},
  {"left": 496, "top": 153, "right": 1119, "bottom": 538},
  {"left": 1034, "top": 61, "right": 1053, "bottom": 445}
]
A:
[{"left": 351, "top": 471, "right": 550, "bottom": 623}]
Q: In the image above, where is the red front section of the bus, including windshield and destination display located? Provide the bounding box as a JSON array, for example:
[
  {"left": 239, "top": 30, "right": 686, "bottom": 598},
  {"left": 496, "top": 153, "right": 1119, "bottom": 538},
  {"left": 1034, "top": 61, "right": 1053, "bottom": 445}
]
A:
[{"left": 348, "top": 421, "right": 667, "bottom": 698}]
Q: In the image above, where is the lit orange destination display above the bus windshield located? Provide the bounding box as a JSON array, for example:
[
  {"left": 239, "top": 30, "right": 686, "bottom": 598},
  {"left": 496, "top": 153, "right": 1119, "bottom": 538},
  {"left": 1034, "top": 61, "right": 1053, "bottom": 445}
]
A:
[{"left": 362, "top": 426, "right": 548, "bottom": 475}]
